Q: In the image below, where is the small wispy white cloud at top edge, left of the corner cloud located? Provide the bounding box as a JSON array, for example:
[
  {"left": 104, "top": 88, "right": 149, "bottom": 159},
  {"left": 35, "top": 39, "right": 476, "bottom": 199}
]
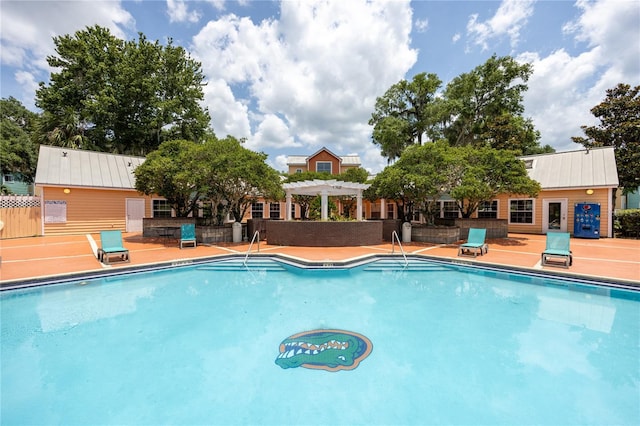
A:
[{"left": 467, "top": 0, "right": 534, "bottom": 50}]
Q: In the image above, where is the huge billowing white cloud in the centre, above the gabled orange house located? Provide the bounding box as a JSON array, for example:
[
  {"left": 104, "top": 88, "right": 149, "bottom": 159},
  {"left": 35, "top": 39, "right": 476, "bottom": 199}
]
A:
[{"left": 192, "top": 0, "right": 417, "bottom": 173}]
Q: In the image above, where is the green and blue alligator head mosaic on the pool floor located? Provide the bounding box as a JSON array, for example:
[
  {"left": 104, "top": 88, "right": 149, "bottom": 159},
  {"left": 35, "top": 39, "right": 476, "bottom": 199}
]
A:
[{"left": 276, "top": 330, "right": 373, "bottom": 371}]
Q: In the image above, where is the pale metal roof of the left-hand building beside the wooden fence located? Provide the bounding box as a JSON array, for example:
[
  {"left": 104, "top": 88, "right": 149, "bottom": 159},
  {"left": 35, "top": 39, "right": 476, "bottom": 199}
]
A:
[{"left": 35, "top": 145, "right": 144, "bottom": 189}]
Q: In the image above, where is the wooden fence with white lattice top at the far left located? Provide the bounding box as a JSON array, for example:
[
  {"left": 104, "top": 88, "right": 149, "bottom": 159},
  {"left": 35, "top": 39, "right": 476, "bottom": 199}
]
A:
[{"left": 0, "top": 195, "right": 42, "bottom": 239}]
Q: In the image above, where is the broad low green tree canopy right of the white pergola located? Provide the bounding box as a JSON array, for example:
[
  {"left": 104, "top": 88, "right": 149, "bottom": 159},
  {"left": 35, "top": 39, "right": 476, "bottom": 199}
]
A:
[{"left": 367, "top": 141, "right": 540, "bottom": 222}]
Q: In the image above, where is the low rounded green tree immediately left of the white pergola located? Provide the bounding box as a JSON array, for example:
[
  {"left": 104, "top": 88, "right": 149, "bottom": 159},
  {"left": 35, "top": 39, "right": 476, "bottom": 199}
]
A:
[{"left": 195, "top": 136, "right": 284, "bottom": 222}]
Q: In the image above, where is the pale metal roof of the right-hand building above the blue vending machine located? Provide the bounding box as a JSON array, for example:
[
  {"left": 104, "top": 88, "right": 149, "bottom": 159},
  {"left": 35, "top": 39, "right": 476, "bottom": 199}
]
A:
[{"left": 520, "top": 147, "right": 618, "bottom": 189}]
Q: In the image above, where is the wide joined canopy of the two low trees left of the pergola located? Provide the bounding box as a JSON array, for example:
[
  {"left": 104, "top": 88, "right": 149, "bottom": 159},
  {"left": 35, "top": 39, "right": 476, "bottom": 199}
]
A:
[{"left": 134, "top": 136, "right": 283, "bottom": 222}]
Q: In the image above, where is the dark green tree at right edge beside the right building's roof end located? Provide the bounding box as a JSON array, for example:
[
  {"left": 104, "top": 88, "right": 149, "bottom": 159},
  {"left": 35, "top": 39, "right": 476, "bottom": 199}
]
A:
[{"left": 571, "top": 83, "right": 640, "bottom": 194}]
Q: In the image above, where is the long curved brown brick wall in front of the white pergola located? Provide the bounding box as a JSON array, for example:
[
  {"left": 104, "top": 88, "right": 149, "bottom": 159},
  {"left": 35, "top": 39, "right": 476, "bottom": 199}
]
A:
[{"left": 266, "top": 220, "right": 382, "bottom": 247}]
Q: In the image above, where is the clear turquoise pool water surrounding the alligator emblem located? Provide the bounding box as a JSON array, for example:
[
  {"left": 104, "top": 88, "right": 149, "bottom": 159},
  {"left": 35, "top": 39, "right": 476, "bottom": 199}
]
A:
[{"left": 0, "top": 259, "right": 640, "bottom": 425}]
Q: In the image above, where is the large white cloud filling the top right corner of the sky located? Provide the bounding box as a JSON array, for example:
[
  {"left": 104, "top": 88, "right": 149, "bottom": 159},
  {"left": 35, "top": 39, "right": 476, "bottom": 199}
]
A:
[{"left": 518, "top": 0, "right": 640, "bottom": 151}]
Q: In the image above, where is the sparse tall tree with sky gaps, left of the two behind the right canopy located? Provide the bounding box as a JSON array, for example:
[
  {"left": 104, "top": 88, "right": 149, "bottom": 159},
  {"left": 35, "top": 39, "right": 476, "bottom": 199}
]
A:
[{"left": 369, "top": 73, "right": 442, "bottom": 160}]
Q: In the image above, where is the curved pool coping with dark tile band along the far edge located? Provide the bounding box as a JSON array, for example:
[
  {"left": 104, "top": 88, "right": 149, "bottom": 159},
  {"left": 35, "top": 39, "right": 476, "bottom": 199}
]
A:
[{"left": 0, "top": 253, "right": 640, "bottom": 292}]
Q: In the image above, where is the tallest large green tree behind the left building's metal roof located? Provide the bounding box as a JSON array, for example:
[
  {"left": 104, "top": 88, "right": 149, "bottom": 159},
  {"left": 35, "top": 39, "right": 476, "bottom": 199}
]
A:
[{"left": 36, "top": 25, "right": 210, "bottom": 155}]
